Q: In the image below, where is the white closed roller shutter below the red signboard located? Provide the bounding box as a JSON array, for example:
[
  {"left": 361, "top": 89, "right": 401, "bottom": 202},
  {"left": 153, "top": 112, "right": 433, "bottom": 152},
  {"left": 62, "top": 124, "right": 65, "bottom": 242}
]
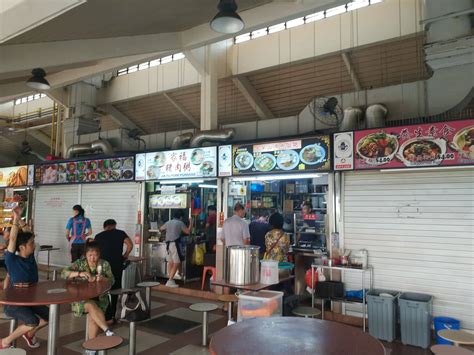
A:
[{"left": 341, "top": 169, "right": 474, "bottom": 329}]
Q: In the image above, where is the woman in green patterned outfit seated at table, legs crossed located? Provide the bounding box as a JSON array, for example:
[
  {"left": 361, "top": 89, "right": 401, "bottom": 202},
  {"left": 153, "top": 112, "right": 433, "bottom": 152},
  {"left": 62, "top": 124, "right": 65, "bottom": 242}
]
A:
[{"left": 61, "top": 241, "right": 114, "bottom": 339}]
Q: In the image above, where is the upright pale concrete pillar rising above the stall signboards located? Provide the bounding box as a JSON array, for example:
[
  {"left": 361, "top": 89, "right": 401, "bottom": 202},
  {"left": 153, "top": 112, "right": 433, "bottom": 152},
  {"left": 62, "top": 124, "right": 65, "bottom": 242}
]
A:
[{"left": 200, "top": 44, "right": 218, "bottom": 131}]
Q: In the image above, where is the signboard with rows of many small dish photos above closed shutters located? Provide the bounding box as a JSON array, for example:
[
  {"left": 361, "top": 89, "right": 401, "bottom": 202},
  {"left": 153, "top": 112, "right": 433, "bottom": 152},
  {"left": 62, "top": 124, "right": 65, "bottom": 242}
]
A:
[{"left": 35, "top": 156, "right": 135, "bottom": 185}]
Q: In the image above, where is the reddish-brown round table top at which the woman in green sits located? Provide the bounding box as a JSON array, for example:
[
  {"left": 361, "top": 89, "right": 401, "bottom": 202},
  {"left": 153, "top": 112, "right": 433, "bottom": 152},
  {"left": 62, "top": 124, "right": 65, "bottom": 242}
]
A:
[{"left": 0, "top": 280, "right": 112, "bottom": 306}]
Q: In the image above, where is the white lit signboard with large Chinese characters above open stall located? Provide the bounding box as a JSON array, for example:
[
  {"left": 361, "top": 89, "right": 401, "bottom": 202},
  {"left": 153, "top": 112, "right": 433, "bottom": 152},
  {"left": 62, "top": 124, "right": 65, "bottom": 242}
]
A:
[{"left": 136, "top": 147, "right": 217, "bottom": 180}]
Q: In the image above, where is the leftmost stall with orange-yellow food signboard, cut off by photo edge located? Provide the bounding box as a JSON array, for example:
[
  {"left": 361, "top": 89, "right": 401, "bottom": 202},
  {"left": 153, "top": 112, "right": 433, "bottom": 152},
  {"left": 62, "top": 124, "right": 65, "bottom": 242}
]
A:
[{"left": 0, "top": 165, "right": 34, "bottom": 242}]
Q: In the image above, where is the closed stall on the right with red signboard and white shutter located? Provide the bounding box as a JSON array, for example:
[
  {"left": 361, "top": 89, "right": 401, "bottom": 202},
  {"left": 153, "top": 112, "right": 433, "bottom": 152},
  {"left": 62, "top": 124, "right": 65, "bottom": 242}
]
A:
[{"left": 334, "top": 119, "right": 474, "bottom": 328}]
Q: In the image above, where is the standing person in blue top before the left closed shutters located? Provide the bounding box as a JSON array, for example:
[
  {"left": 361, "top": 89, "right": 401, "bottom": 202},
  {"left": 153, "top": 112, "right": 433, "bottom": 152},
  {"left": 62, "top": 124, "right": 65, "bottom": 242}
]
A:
[{"left": 66, "top": 205, "right": 92, "bottom": 262}]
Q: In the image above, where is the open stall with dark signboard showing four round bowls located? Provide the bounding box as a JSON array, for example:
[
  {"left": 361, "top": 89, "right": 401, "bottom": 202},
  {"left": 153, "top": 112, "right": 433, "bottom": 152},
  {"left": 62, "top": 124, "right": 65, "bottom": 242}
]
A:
[{"left": 219, "top": 135, "right": 332, "bottom": 294}]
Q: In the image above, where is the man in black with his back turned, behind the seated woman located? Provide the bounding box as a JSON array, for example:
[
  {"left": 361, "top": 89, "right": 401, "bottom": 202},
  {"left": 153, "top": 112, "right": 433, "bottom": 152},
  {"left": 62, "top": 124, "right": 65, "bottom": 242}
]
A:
[{"left": 94, "top": 219, "right": 133, "bottom": 323}]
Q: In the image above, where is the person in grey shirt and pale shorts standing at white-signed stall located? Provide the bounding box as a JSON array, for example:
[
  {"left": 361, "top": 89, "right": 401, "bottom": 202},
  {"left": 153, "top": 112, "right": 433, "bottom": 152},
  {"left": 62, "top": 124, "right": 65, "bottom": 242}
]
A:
[{"left": 160, "top": 210, "right": 192, "bottom": 287}]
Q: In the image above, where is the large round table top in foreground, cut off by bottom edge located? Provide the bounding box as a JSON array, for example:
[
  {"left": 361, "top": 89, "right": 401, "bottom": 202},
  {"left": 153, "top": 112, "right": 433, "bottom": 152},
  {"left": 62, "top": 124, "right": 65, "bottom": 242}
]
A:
[{"left": 209, "top": 317, "right": 385, "bottom": 355}]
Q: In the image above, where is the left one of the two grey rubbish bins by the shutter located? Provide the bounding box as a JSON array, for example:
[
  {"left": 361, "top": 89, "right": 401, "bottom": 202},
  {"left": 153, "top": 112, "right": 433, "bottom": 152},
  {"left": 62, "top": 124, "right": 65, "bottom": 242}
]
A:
[{"left": 367, "top": 290, "right": 400, "bottom": 342}]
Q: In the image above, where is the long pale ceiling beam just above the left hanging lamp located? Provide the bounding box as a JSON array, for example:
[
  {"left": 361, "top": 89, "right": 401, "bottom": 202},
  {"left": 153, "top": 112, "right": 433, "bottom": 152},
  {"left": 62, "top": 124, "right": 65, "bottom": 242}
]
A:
[{"left": 0, "top": 32, "right": 181, "bottom": 78}]
